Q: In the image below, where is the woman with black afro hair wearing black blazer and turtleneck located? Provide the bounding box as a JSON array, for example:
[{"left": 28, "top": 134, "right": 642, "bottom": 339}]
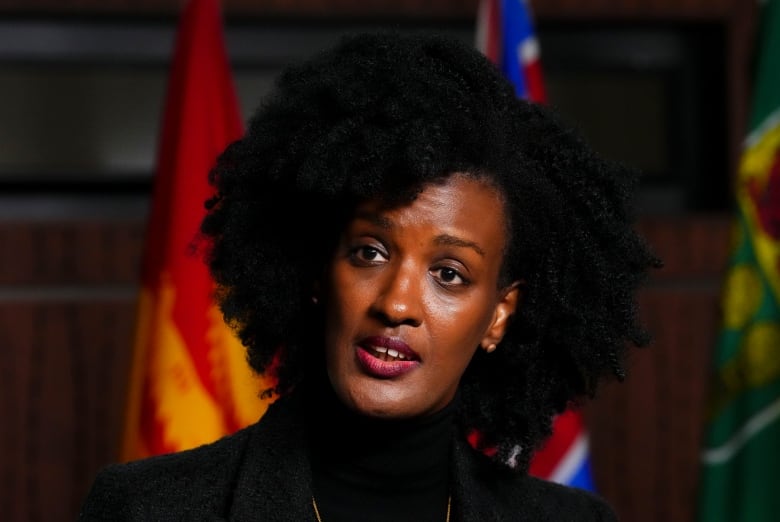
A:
[{"left": 81, "top": 34, "right": 658, "bottom": 522}]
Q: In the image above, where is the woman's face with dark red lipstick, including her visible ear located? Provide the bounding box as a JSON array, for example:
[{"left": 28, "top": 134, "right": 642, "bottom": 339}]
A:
[{"left": 322, "top": 174, "right": 519, "bottom": 418}]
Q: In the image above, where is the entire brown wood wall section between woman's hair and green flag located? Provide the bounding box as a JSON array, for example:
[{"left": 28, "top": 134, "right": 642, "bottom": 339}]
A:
[{"left": 585, "top": 212, "right": 731, "bottom": 522}]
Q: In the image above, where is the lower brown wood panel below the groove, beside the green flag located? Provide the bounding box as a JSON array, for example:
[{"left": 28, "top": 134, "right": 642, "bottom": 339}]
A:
[{"left": 588, "top": 289, "right": 718, "bottom": 522}]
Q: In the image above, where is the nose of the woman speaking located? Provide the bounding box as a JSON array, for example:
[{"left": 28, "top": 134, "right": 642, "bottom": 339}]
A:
[{"left": 371, "top": 264, "right": 425, "bottom": 326}]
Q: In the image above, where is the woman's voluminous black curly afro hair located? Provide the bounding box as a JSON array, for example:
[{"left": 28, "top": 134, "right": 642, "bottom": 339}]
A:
[{"left": 201, "top": 33, "right": 660, "bottom": 470}]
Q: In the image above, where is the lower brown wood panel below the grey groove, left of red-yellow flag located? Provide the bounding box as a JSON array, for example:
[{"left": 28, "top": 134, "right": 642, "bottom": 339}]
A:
[{"left": 0, "top": 300, "right": 134, "bottom": 522}]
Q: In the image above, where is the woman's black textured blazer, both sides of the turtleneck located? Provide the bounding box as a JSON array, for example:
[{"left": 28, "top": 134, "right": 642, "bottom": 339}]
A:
[{"left": 79, "top": 394, "right": 616, "bottom": 522}]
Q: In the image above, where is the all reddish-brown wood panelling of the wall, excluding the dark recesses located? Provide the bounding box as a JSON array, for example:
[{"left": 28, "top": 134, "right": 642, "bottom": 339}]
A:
[{"left": 0, "top": 0, "right": 755, "bottom": 522}]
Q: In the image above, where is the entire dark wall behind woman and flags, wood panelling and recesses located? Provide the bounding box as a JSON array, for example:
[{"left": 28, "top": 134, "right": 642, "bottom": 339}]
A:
[{"left": 0, "top": 0, "right": 755, "bottom": 522}]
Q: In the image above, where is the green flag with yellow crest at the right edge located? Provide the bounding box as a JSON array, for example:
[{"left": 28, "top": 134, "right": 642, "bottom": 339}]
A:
[{"left": 699, "top": 0, "right": 780, "bottom": 522}]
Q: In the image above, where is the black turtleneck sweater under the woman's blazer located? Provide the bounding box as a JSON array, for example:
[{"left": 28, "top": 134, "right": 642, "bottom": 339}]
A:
[{"left": 308, "top": 378, "right": 456, "bottom": 522}]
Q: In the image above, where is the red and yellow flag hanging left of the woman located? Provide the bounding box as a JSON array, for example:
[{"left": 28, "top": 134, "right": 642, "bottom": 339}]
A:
[{"left": 121, "top": 0, "right": 267, "bottom": 460}]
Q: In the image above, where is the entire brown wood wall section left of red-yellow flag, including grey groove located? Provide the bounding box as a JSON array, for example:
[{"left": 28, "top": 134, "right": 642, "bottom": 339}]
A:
[{"left": 0, "top": 220, "right": 144, "bottom": 522}]
